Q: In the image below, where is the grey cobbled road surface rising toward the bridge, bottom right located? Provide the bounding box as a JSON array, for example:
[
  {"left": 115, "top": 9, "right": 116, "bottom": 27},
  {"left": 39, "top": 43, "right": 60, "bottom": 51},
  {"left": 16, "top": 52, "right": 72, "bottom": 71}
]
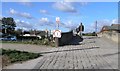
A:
[{"left": 34, "top": 38, "right": 118, "bottom": 69}]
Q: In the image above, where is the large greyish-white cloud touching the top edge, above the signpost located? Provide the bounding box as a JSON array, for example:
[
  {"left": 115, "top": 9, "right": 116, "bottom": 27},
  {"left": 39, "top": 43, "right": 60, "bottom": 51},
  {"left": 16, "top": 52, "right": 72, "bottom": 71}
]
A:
[{"left": 53, "top": 2, "right": 77, "bottom": 13}]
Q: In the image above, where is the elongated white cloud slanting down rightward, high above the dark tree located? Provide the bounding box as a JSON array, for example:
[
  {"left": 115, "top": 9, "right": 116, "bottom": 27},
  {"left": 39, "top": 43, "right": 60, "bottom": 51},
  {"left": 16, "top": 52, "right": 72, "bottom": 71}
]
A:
[{"left": 9, "top": 8, "right": 33, "bottom": 19}]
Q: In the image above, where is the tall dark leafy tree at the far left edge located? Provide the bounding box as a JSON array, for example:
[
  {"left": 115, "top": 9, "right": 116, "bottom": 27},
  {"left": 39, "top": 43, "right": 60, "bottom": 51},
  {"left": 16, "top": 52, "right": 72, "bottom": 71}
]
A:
[{"left": 2, "top": 17, "right": 16, "bottom": 35}]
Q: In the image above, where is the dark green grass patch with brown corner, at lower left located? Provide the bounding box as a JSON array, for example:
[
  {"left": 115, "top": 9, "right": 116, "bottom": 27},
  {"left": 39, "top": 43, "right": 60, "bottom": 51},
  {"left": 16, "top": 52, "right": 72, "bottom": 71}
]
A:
[{"left": 1, "top": 49, "right": 41, "bottom": 66}]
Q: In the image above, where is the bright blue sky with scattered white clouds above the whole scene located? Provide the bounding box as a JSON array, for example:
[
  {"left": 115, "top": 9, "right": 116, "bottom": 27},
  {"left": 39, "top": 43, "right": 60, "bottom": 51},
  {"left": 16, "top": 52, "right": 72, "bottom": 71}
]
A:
[{"left": 2, "top": 1, "right": 118, "bottom": 32}]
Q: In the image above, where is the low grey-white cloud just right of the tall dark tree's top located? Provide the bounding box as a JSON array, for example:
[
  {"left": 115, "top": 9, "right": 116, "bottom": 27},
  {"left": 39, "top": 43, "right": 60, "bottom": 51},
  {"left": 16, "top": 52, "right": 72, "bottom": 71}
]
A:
[{"left": 15, "top": 19, "right": 35, "bottom": 30}]
